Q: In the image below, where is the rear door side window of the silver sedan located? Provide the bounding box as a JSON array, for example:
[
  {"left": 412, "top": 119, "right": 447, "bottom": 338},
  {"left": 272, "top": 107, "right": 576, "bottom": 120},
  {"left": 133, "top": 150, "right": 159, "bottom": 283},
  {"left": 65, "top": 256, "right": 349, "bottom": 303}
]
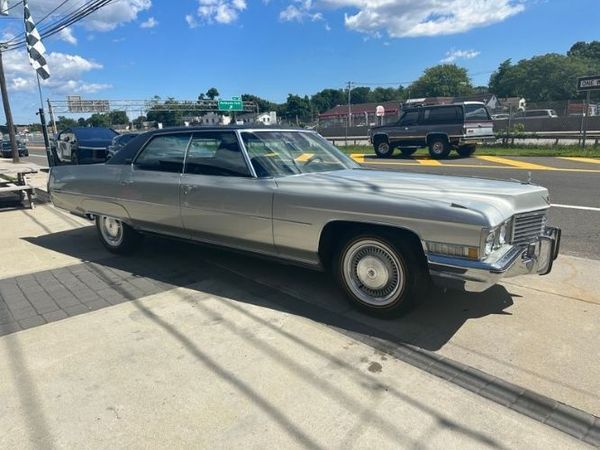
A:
[{"left": 134, "top": 133, "right": 191, "bottom": 173}]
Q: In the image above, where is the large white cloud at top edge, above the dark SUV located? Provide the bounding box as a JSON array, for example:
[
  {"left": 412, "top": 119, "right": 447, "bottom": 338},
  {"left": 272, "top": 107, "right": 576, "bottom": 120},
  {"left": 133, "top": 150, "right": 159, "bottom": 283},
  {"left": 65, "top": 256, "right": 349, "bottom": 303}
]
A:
[{"left": 282, "top": 0, "right": 526, "bottom": 38}]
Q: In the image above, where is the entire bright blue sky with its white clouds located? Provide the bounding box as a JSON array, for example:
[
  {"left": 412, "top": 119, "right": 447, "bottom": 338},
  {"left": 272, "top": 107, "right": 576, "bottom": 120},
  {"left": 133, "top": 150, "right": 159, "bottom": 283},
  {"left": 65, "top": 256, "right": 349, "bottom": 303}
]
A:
[{"left": 0, "top": 0, "right": 600, "bottom": 123}]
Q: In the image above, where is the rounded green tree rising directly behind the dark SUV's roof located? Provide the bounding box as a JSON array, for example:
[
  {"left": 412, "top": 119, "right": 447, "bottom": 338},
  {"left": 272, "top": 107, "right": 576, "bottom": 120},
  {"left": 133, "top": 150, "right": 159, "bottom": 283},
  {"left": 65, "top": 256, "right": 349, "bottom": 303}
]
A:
[{"left": 410, "top": 64, "right": 473, "bottom": 97}]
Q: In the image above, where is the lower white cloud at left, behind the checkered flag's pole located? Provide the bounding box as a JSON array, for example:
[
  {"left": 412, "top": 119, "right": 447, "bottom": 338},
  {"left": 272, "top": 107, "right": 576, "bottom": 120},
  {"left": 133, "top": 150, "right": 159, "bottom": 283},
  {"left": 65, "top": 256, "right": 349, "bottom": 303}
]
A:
[{"left": 4, "top": 51, "right": 112, "bottom": 95}]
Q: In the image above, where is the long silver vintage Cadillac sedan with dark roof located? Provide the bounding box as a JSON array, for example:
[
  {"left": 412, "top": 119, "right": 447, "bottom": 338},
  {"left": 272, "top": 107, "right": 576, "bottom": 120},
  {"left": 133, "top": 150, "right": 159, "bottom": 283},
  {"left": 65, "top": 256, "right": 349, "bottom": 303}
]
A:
[{"left": 49, "top": 127, "right": 560, "bottom": 315}]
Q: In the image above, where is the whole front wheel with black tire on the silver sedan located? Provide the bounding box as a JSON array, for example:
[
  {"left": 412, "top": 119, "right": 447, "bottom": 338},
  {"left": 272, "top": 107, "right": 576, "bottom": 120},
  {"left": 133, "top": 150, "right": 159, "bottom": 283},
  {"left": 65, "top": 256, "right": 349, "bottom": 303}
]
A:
[{"left": 336, "top": 235, "right": 423, "bottom": 317}]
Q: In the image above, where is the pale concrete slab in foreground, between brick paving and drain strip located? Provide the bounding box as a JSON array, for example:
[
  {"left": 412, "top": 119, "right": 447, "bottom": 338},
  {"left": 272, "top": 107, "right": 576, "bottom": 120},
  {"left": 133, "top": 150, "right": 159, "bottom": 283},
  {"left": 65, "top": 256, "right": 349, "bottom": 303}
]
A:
[{"left": 0, "top": 280, "right": 582, "bottom": 448}]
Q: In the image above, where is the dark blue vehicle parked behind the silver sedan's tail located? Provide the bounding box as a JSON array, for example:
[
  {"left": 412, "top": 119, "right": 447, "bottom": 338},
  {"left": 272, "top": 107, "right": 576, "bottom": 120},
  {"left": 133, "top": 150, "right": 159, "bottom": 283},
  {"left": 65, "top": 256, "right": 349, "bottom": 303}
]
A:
[{"left": 56, "top": 127, "right": 119, "bottom": 164}]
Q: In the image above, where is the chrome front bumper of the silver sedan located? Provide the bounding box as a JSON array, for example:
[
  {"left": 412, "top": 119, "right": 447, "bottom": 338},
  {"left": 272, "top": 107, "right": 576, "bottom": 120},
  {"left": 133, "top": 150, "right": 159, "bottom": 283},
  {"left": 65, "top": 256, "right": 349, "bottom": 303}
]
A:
[{"left": 427, "top": 227, "right": 561, "bottom": 292}]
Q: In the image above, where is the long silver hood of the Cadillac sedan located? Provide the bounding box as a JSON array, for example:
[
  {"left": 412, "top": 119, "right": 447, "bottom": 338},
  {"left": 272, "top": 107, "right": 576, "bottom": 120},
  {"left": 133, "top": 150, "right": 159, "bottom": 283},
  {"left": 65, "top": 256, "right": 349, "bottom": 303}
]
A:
[{"left": 277, "top": 169, "right": 550, "bottom": 226}]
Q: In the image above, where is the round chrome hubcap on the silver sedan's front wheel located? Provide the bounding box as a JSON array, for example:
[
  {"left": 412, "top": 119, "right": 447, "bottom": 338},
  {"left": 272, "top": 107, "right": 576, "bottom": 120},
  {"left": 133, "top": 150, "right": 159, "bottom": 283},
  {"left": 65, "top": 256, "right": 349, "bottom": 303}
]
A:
[{"left": 343, "top": 240, "right": 406, "bottom": 307}]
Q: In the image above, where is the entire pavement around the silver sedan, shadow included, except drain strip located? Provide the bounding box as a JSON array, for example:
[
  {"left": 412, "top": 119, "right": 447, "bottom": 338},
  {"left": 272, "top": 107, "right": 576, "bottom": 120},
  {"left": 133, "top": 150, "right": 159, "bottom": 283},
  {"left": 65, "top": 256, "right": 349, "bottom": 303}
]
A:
[{"left": 0, "top": 206, "right": 600, "bottom": 448}]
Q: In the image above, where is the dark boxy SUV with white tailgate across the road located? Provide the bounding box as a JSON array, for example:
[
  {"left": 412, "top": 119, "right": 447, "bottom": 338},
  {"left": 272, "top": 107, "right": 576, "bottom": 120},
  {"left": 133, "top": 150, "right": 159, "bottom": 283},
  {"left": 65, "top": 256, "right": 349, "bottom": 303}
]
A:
[{"left": 370, "top": 102, "right": 495, "bottom": 158}]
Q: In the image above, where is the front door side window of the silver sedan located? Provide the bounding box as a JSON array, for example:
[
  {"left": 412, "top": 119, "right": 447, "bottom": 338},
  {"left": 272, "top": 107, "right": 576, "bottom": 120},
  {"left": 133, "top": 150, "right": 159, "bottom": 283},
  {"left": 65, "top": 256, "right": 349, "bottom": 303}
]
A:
[{"left": 185, "top": 131, "right": 250, "bottom": 177}]
